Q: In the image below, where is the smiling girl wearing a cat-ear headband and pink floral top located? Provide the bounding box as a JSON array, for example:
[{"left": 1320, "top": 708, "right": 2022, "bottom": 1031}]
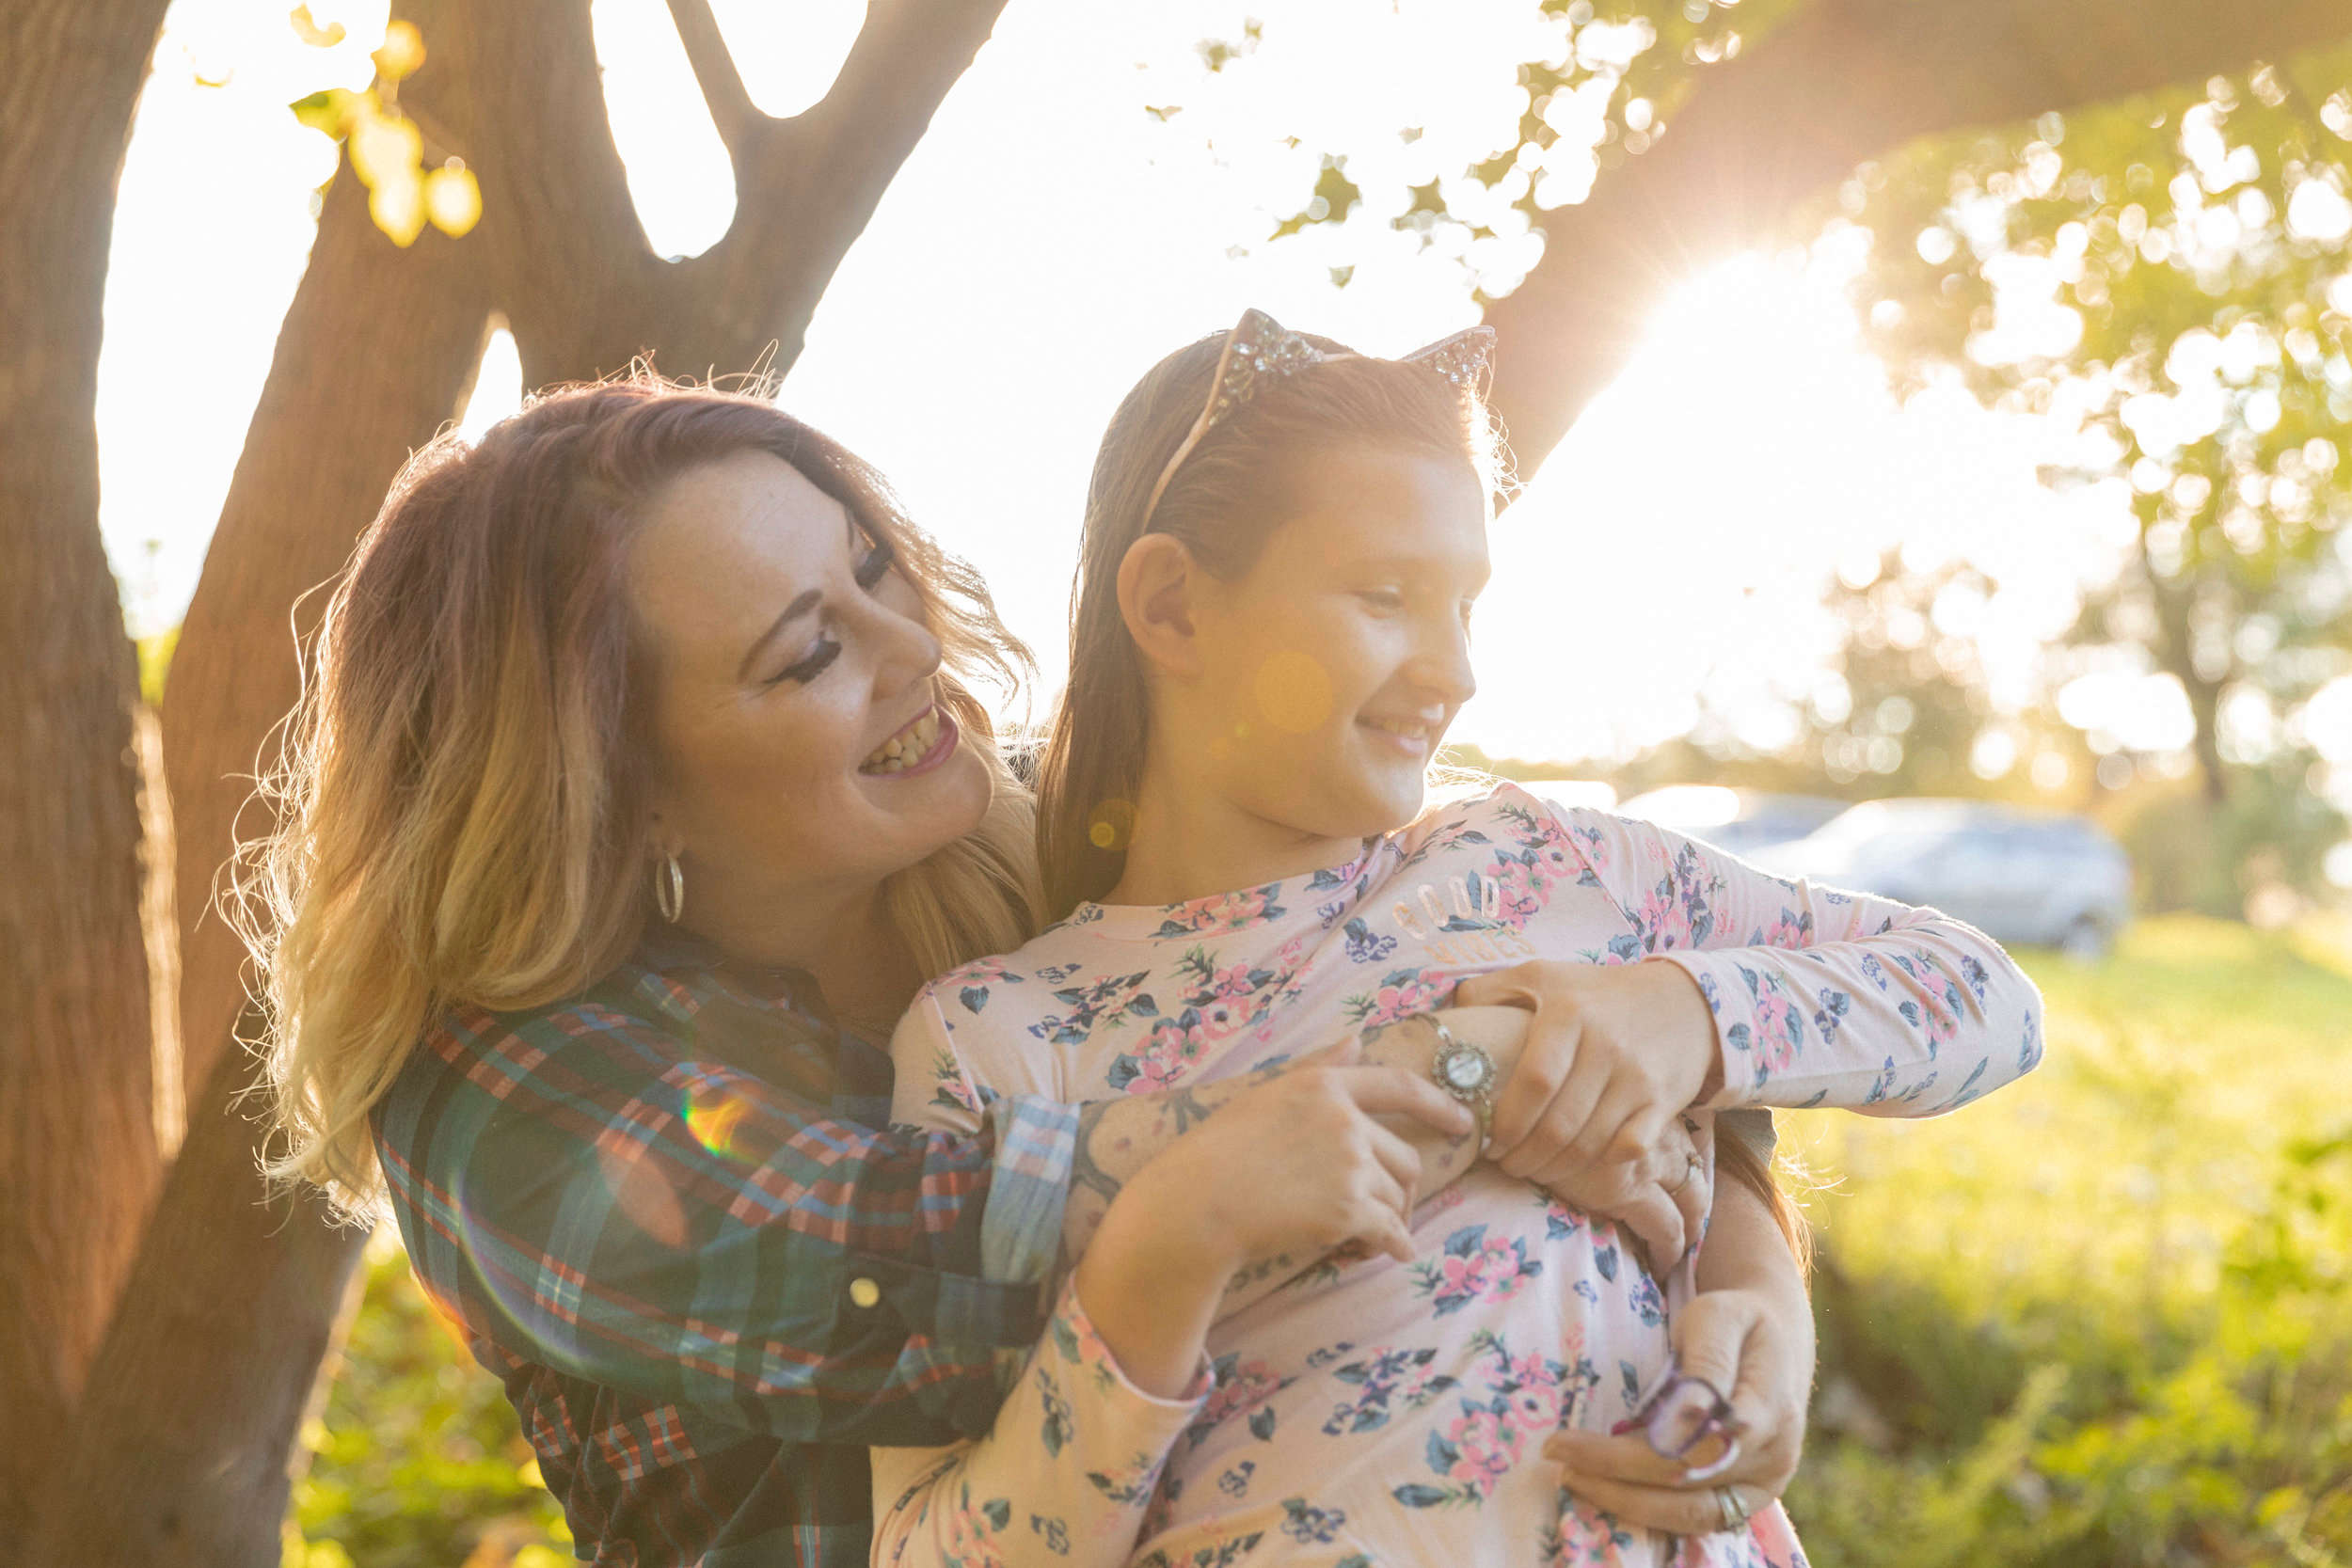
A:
[{"left": 875, "top": 312, "right": 2040, "bottom": 1568}]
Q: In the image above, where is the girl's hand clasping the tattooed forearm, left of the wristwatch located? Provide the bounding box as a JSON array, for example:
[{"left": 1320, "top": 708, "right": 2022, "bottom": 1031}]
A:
[{"left": 1105, "top": 1039, "right": 1475, "bottom": 1272}]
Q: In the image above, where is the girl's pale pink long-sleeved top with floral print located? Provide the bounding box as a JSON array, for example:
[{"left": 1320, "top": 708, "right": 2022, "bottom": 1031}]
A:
[{"left": 873, "top": 785, "right": 2042, "bottom": 1568}]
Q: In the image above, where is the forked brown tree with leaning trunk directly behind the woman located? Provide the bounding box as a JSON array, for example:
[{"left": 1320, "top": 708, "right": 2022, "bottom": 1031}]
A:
[{"left": 33, "top": 0, "right": 1002, "bottom": 1568}]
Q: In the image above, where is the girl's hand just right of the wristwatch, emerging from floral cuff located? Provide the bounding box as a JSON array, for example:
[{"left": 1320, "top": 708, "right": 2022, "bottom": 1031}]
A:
[{"left": 1454, "top": 959, "right": 1720, "bottom": 1267}]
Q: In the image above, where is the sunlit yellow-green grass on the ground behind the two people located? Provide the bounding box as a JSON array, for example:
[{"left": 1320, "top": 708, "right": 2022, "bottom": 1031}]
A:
[{"left": 287, "top": 919, "right": 2352, "bottom": 1568}]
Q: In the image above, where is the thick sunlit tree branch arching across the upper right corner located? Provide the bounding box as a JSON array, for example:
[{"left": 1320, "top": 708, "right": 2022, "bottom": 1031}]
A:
[{"left": 1486, "top": 0, "right": 2352, "bottom": 475}]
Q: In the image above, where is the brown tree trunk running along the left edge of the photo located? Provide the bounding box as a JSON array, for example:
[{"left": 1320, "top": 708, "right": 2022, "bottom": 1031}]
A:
[{"left": 0, "top": 0, "right": 179, "bottom": 1561}]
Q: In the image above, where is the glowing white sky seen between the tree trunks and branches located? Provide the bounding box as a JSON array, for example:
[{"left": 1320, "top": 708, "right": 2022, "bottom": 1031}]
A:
[{"left": 99, "top": 0, "right": 2220, "bottom": 775}]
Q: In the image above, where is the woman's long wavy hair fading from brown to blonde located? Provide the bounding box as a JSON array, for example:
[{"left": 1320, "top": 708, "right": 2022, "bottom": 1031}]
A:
[{"left": 235, "top": 369, "right": 1038, "bottom": 1213}]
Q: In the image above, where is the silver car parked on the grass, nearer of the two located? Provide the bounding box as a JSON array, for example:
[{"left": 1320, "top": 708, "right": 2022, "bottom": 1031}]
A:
[{"left": 1753, "top": 800, "right": 2131, "bottom": 959}]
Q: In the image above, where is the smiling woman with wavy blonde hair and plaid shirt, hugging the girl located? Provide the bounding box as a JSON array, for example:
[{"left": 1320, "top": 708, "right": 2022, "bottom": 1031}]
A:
[{"left": 245, "top": 376, "right": 1811, "bottom": 1568}]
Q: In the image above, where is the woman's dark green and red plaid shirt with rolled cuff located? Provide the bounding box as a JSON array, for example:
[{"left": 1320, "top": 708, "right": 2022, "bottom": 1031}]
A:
[{"left": 374, "top": 933, "right": 1077, "bottom": 1568}]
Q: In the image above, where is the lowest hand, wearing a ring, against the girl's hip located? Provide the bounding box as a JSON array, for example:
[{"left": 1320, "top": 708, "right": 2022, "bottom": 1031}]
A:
[{"left": 1543, "top": 1291, "right": 1814, "bottom": 1535}]
